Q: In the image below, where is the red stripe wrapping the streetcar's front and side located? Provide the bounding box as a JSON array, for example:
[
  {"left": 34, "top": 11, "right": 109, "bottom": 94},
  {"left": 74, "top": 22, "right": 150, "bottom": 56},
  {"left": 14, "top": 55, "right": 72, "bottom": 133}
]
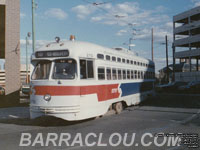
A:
[{"left": 34, "top": 84, "right": 120, "bottom": 101}]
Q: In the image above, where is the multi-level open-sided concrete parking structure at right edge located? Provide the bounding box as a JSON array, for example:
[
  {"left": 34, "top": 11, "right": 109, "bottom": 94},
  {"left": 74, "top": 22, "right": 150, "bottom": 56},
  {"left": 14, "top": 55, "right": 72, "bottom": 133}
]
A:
[{"left": 173, "top": 6, "right": 200, "bottom": 81}]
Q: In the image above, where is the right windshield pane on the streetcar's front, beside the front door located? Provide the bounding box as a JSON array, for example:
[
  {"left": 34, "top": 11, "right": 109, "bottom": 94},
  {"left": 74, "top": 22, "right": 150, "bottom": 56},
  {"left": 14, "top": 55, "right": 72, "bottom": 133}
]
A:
[{"left": 52, "top": 59, "right": 76, "bottom": 79}]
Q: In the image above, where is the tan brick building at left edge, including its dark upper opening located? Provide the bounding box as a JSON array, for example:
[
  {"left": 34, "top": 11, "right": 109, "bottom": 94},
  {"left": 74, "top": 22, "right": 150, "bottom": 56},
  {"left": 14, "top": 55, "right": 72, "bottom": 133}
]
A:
[{"left": 0, "top": 0, "right": 20, "bottom": 95}]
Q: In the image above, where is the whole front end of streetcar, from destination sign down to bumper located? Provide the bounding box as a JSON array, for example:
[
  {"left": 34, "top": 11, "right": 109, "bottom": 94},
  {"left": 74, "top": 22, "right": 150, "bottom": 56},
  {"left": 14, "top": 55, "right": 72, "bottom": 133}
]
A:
[{"left": 30, "top": 50, "right": 80, "bottom": 120}]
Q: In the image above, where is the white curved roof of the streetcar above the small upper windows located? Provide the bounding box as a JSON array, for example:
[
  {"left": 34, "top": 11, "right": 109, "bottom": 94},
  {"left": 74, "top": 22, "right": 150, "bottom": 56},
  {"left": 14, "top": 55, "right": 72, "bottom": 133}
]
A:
[{"left": 33, "top": 41, "right": 152, "bottom": 63}]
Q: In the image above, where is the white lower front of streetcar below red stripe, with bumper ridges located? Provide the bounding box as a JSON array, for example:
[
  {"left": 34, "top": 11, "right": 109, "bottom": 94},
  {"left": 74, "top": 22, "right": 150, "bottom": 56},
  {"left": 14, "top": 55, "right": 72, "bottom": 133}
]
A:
[{"left": 30, "top": 95, "right": 81, "bottom": 120}]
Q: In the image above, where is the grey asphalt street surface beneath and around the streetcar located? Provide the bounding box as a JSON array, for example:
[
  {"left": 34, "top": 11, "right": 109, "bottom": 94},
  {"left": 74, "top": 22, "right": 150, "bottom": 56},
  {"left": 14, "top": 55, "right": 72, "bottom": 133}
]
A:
[{"left": 0, "top": 99, "right": 200, "bottom": 150}]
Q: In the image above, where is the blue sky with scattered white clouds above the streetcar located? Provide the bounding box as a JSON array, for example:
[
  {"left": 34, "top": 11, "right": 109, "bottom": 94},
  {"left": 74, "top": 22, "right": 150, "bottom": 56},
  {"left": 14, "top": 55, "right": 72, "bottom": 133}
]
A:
[{"left": 1, "top": 0, "right": 200, "bottom": 70}]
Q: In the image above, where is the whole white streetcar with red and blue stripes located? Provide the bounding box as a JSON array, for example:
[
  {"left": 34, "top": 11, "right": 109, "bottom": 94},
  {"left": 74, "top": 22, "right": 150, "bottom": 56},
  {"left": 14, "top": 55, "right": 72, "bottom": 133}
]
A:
[{"left": 30, "top": 36, "right": 155, "bottom": 121}]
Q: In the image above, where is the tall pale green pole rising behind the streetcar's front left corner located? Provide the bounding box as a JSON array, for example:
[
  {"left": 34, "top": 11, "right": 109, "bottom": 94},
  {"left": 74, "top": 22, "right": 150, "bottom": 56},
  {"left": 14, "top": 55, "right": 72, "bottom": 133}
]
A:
[{"left": 32, "top": 0, "right": 36, "bottom": 53}]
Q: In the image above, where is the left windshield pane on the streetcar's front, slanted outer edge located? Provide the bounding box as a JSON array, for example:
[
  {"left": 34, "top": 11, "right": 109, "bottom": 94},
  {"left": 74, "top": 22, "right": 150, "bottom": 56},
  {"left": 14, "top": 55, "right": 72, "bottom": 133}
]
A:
[{"left": 32, "top": 60, "right": 51, "bottom": 80}]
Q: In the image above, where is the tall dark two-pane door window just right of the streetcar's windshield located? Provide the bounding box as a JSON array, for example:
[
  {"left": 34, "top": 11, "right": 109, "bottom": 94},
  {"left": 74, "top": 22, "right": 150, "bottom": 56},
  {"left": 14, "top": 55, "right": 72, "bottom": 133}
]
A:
[{"left": 80, "top": 59, "right": 94, "bottom": 79}]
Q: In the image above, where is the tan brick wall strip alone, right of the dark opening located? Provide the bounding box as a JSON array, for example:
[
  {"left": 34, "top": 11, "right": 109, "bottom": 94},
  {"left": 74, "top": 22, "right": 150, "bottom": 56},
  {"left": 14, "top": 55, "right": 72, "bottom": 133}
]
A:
[{"left": 5, "top": 0, "right": 20, "bottom": 95}]
